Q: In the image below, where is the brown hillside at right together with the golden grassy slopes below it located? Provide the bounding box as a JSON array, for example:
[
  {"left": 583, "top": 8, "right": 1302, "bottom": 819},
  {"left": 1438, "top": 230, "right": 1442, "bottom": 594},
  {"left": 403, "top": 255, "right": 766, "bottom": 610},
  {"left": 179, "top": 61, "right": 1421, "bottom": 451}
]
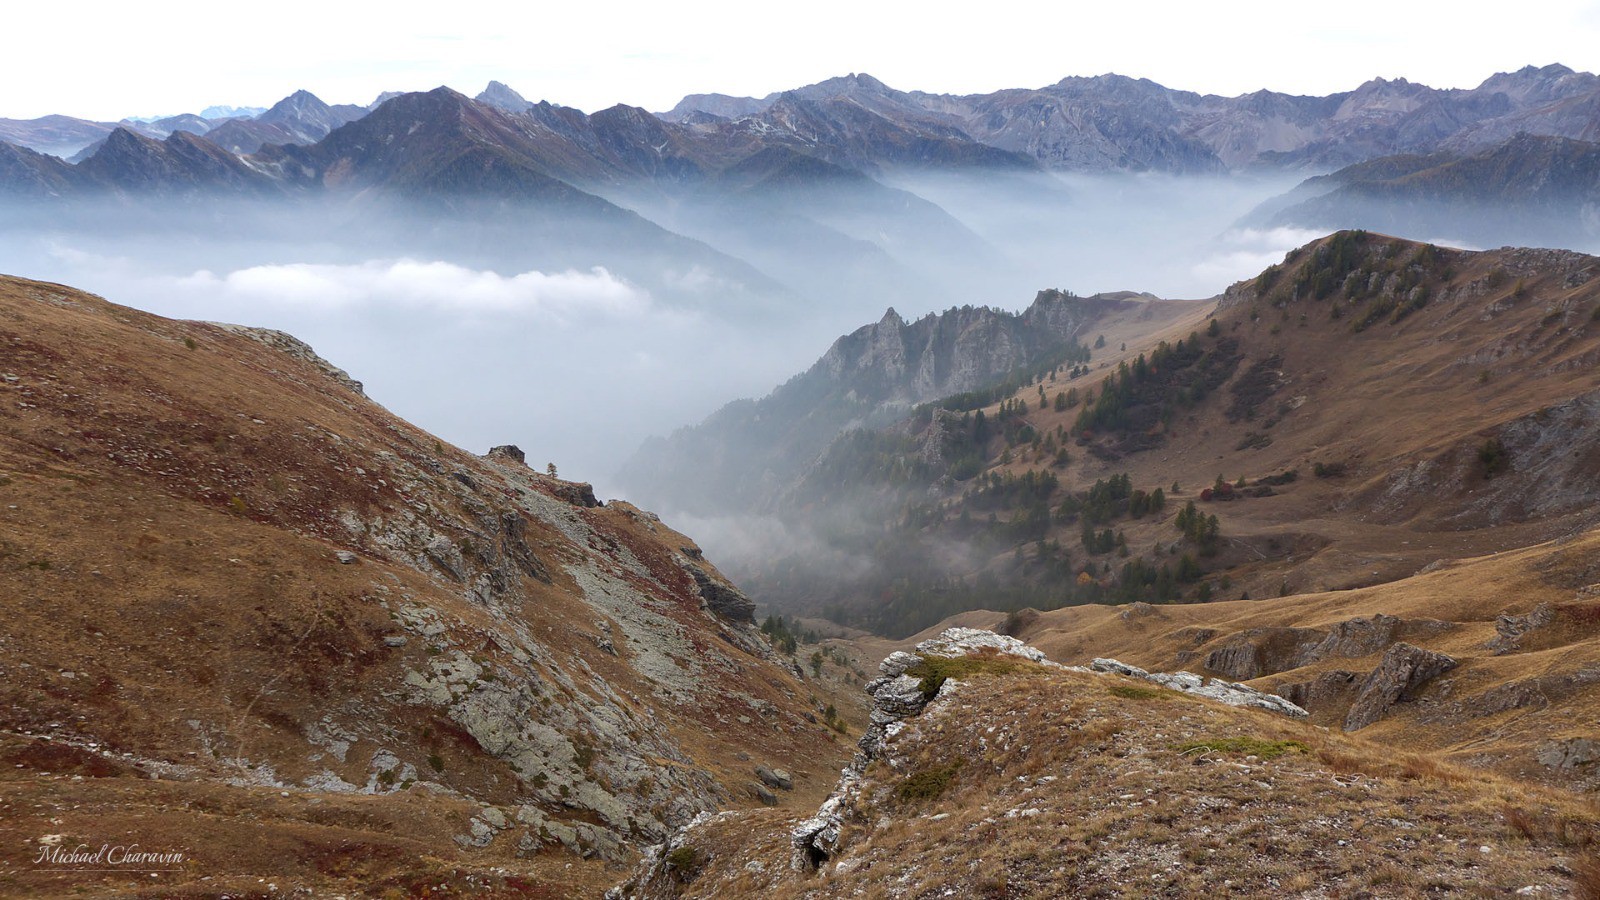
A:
[{"left": 825, "top": 232, "right": 1600, "bottom": 790}]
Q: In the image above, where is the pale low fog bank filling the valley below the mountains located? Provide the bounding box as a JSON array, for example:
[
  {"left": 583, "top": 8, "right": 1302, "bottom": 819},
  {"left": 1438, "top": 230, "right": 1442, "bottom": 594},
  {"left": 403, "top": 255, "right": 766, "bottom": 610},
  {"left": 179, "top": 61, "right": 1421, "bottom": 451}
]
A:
[{"left": 0, "top": 175, "right": 1314, "bottom": 496}]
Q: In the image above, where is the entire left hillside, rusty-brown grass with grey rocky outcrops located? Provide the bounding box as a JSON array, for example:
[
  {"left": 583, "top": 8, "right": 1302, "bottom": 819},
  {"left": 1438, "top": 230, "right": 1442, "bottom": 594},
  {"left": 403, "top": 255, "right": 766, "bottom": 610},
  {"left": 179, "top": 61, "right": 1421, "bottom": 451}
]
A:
[{"left": 0, "top": 279, "right": 861, "bottom": 897}]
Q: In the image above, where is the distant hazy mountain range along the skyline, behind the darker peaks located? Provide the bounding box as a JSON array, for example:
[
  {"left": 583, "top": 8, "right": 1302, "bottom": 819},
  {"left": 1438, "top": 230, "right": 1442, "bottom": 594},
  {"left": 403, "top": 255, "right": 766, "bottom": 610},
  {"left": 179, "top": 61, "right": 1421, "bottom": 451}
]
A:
[{"left": 0, "top": 64, "right": 1600, "bottom": 190}]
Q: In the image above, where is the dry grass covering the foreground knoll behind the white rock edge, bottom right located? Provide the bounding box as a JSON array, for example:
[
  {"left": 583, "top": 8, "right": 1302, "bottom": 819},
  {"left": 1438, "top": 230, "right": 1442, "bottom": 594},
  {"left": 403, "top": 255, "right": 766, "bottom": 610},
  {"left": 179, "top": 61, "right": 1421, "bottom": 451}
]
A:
[{"left": 652, "top": 662, "right": 1600, "bottom": 900}]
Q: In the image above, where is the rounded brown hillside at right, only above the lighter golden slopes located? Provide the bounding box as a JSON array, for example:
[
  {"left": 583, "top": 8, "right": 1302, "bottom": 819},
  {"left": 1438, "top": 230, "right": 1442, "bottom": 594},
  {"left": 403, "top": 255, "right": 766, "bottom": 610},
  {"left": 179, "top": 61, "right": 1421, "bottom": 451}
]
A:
[{"left": 953, "top": 232, "right": 1600, "bottom": 597}]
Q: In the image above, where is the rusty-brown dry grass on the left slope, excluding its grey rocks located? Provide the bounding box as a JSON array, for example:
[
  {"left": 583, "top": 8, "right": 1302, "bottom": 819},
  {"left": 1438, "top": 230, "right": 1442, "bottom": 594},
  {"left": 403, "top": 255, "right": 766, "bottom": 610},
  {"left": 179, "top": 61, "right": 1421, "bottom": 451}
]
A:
[{"left": 0, "top": 279, "right": 862, "bottom": 897}]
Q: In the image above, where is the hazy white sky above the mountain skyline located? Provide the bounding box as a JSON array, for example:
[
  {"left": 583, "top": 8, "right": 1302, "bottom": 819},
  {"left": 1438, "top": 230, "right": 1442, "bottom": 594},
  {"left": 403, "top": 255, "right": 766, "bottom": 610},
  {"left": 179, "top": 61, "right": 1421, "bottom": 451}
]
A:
[{"left": 9, "top": 0, "right": 1600, "bottom": 120}]
